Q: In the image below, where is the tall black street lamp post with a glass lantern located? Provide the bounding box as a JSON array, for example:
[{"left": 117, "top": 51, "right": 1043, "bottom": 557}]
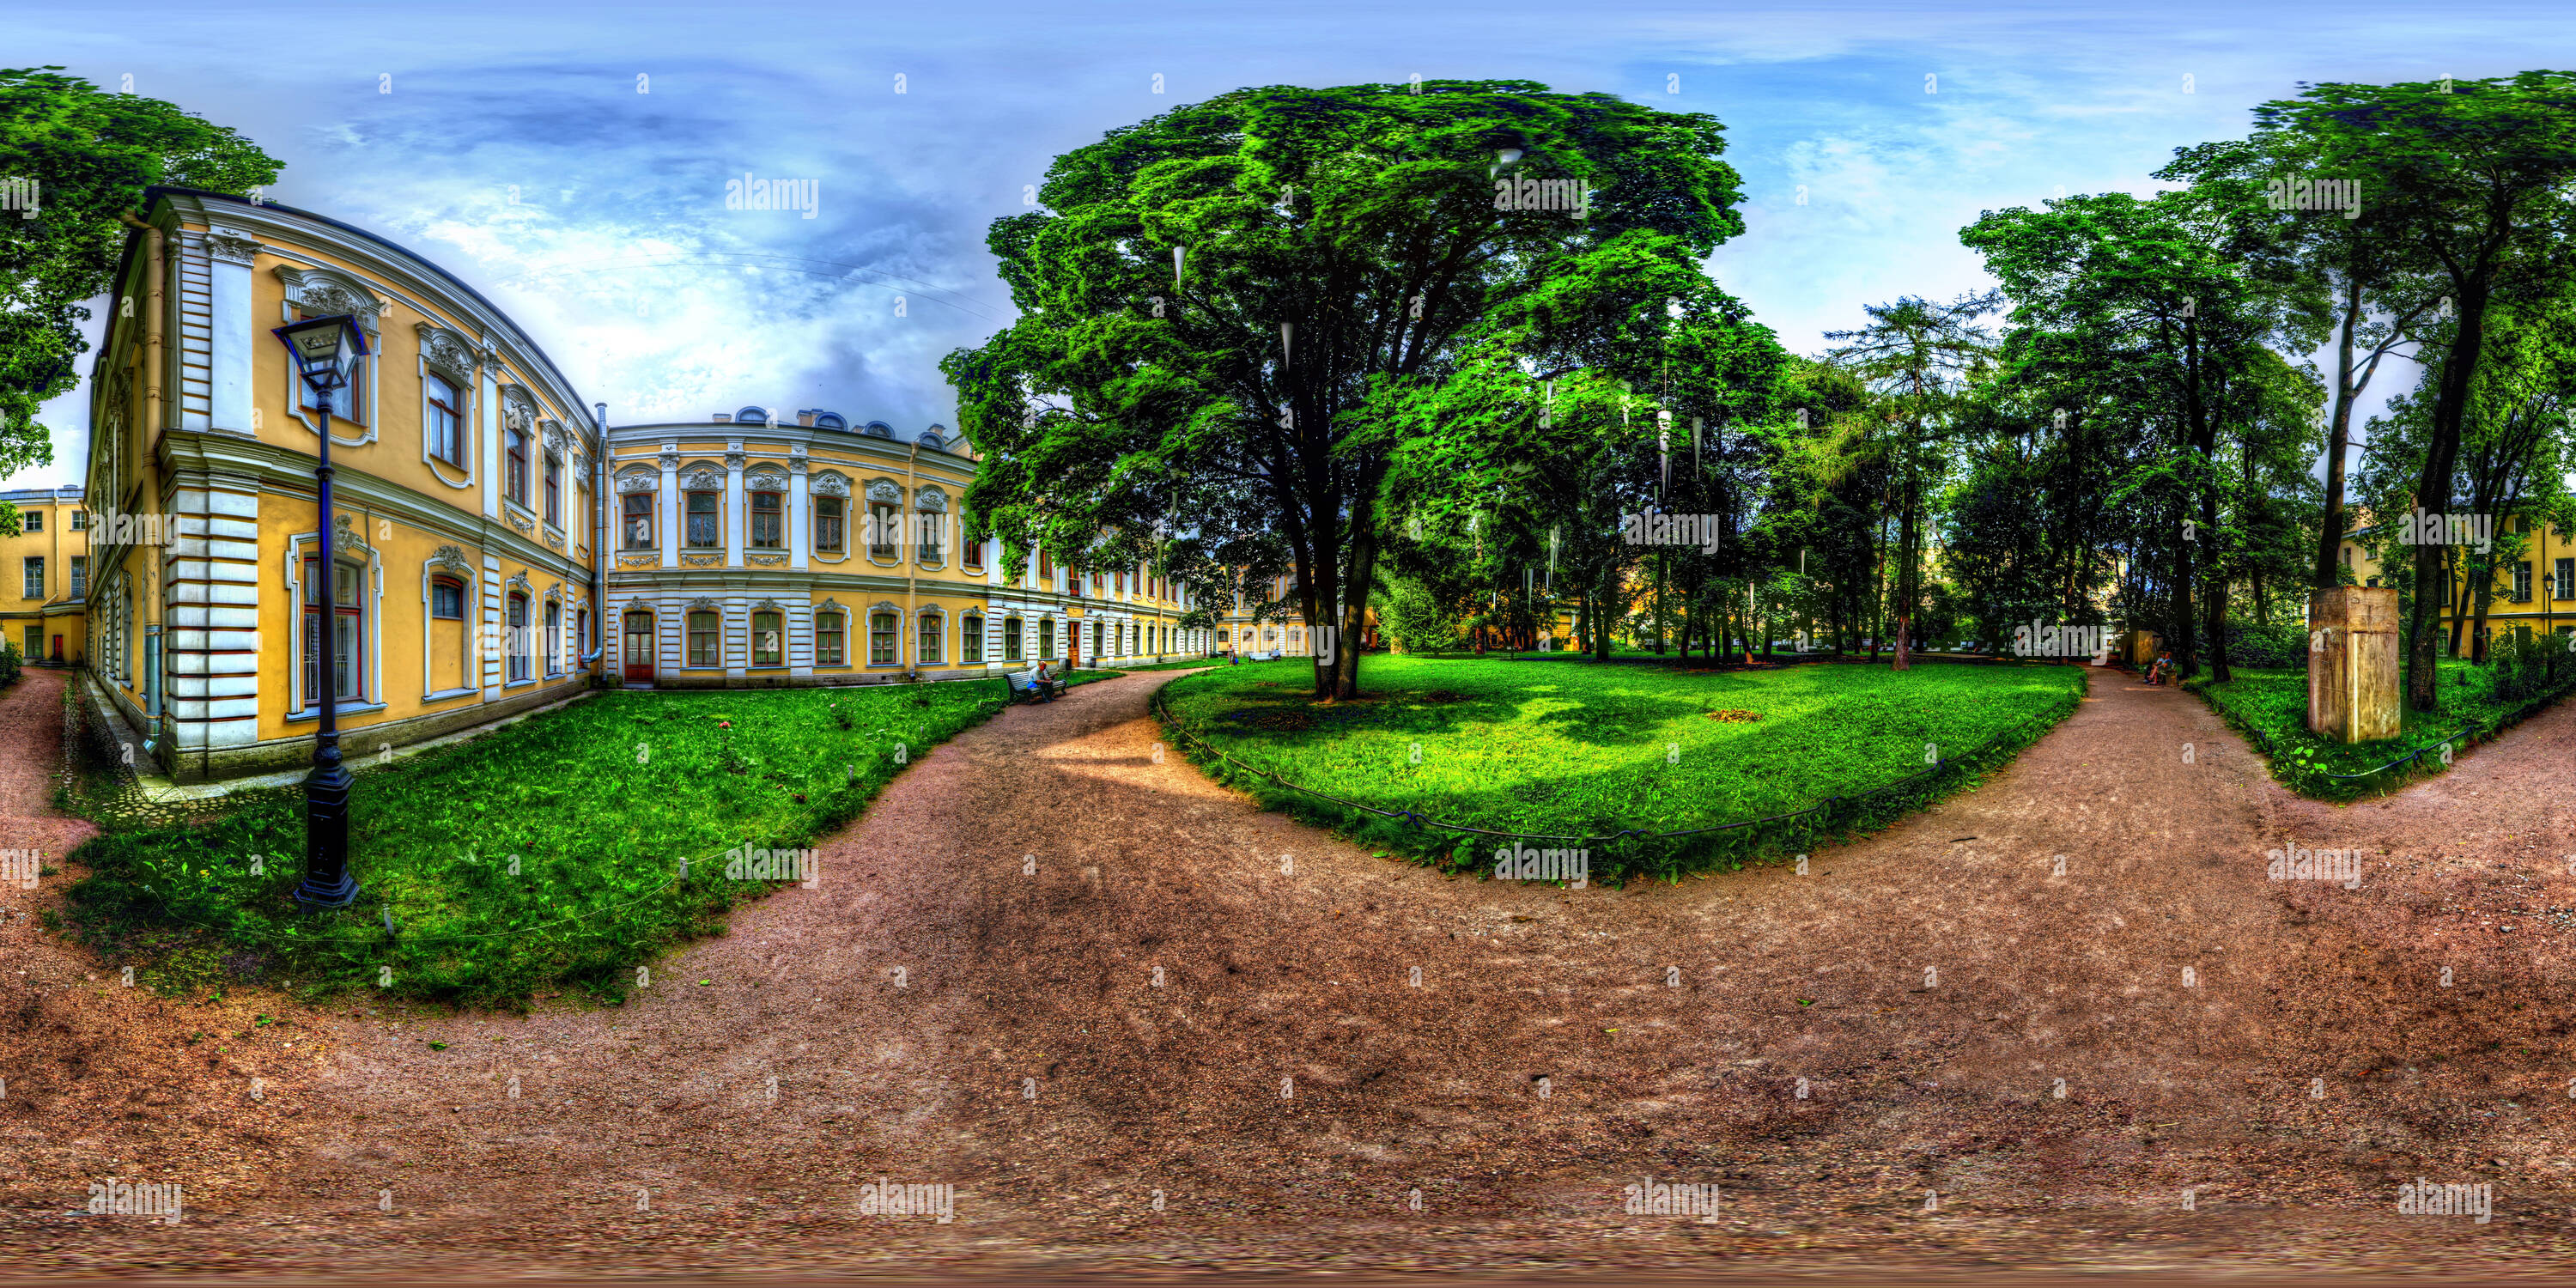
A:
[{"left": 273, "top": 314, "right": 366, "bottom": 909}]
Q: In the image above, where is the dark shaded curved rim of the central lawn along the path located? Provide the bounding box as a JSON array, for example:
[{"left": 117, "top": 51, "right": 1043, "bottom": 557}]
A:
[{"left": 1149, "top": 659, "right": 2089, "bottom": 884}]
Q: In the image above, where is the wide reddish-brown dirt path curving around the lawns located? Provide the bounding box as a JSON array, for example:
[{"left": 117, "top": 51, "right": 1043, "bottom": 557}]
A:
[{"left": 10, "top": 672, "right": 2576, "bottom": 1273}]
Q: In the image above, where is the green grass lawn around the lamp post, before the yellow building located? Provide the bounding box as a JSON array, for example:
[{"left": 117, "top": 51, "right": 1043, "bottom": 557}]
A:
[{"left": 70, "top": 670, "right": 1115, "bottom": 1005}]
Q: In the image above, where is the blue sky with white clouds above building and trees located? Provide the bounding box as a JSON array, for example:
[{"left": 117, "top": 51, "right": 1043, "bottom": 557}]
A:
[{"left": 25, "top": 0, "right": 2576, "bottom": 487}]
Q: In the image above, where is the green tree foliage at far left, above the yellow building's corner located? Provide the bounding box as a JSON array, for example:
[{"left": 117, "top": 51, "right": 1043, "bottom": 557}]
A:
[{"left": 0, "top": 67, "right": 278, "bottom": 474}]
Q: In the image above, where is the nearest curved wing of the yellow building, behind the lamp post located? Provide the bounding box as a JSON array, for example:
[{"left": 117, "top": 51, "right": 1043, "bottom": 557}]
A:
[{"left": 85, "top": 188, "right": 598, "bottom": 781}]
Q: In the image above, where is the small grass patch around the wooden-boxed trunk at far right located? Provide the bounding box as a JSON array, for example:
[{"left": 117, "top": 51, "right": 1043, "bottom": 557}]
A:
[{"left": 2184, "top": 657, "right": 2576, "bottom": 801}]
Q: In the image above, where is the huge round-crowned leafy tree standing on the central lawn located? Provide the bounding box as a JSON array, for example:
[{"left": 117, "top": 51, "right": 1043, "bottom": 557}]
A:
[{"left": 943, "top": 80, "right": 1757, "bottom": 698}]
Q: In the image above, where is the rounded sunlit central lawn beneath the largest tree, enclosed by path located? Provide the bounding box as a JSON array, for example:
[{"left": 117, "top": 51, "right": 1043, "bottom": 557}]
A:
[{"left": 1167, "top": 657, "right": 2084, "bottom": 876}]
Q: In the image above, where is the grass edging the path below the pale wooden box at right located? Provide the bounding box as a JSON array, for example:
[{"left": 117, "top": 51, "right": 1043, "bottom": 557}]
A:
[{"left": 2182, "top": 659, "right": 2576, "bottom": 804}]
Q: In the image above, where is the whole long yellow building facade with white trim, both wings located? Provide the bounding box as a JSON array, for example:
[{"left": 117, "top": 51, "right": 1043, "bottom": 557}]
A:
[{"left": 77, "top": 188, "right": 1303, "bottom": 781}]
